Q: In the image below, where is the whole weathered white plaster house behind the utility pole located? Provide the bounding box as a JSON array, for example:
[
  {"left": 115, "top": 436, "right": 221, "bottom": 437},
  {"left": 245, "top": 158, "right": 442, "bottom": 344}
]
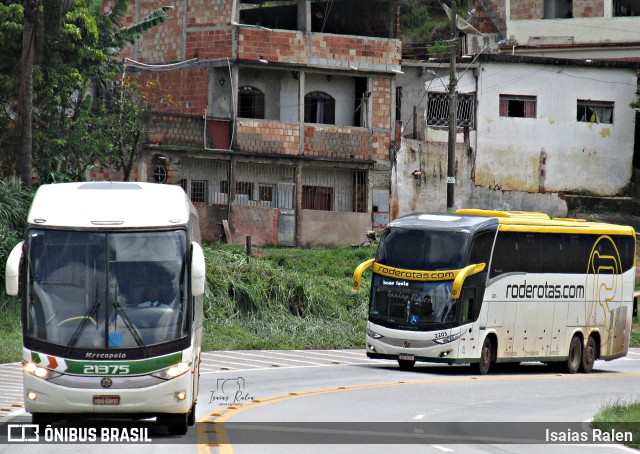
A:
[{"left": 391, "top": 54, "right": 638, "bottom": 216}]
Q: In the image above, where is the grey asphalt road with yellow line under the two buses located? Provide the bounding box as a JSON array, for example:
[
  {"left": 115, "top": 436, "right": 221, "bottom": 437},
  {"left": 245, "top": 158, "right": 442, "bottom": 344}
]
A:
[{"left": 0, "top": 349, "right": 640, "bottom": 454}]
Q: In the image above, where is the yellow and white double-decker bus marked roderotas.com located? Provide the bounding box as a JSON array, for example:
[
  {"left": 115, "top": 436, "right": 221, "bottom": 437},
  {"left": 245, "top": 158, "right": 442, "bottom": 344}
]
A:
[{"left": 354, "top": 209, "right": 636, "bottom": 374}]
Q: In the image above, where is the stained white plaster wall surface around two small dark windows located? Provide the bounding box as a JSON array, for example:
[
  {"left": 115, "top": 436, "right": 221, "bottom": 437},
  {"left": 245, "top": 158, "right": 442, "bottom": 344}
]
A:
[{"left": 472, "top": 63, "right": 636, "bottom": 196}]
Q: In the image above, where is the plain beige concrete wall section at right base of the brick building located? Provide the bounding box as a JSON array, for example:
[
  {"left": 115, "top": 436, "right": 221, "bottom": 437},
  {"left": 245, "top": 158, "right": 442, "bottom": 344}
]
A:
[{"left": 300, "top": 210, "right": 371, "bottom": 247}]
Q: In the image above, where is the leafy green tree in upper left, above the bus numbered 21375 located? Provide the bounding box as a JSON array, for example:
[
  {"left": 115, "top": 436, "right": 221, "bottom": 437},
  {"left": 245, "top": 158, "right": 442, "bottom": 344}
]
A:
[{"left": 0, "top": 0, "right": 170, "bottom": 187}]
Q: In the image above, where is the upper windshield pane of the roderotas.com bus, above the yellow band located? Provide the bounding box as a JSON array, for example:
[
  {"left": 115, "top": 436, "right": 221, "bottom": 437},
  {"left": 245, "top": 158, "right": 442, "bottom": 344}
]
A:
[{"left": 376, "top": 227, "right": 469, "bottom": 271}]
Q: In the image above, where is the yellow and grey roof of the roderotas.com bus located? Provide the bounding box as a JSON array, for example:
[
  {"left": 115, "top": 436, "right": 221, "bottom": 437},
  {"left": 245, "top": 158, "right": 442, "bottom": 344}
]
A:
[{"left": 389, "top": 209, "right": 635, "bottom": 236}]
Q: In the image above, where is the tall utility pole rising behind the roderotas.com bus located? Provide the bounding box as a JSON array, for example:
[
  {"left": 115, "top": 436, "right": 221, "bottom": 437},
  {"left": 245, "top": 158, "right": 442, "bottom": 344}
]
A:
[{"left": 447, "top": 0, "right": 458, "bottom": 211}]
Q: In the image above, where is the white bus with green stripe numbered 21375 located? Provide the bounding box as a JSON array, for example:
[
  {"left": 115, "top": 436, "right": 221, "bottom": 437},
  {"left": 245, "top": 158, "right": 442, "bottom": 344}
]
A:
[{"left": 6, "top": 182, "right": 205, "bottom": 434}]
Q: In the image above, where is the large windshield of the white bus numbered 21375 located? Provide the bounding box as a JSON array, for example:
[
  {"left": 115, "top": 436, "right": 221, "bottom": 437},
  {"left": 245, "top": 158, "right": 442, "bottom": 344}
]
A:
[{"left": 24, "top": 229, "right": 189, "bottom": 350}]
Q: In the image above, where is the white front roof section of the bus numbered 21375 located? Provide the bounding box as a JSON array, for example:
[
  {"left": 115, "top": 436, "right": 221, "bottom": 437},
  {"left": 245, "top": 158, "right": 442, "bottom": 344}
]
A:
[{"left": 27, "top": 182, "right": 191, "bottom": 228}]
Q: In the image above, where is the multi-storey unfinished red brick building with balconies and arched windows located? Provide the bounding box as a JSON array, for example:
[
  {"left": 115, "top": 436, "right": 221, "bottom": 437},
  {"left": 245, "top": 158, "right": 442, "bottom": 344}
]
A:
[{"left": 105, "top": 0, "right": 401, "bottom": 246}]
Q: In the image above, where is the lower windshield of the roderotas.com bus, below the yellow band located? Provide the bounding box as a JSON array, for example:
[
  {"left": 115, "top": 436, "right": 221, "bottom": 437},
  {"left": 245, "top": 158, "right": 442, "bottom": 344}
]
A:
[{"left": 369, "top": 274, "right": 458, "bottom": 331}]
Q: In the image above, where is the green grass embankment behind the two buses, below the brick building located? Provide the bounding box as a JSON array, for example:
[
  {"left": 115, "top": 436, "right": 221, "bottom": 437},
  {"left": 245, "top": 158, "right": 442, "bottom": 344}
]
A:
[{"left": 0, "top": 243, "right": 375, "bottom": 363}]
